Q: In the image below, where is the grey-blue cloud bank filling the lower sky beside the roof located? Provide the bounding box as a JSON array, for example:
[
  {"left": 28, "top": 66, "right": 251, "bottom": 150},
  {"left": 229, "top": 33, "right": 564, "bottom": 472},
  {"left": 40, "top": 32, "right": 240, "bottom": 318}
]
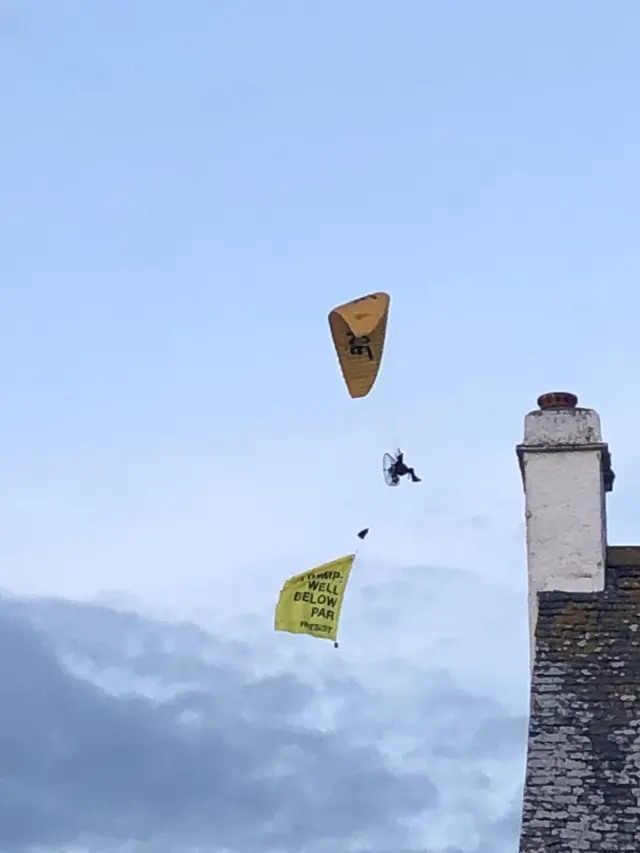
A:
[{"left": 0, "top": 564, "right": 525, "bottom": 853}]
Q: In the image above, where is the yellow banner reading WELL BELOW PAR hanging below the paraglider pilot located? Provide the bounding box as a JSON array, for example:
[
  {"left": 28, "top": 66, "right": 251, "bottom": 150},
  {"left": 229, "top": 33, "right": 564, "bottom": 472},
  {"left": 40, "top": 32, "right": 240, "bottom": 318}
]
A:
[{"left": 275, "top": 554, "right": 355, "bottom": 640}]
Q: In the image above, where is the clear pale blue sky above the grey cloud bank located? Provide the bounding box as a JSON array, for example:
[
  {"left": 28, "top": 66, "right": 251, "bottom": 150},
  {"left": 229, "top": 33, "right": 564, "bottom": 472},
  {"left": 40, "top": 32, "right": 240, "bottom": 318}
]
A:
[{"left": 0, "top": 0, "right": 640, "bottom": 850}]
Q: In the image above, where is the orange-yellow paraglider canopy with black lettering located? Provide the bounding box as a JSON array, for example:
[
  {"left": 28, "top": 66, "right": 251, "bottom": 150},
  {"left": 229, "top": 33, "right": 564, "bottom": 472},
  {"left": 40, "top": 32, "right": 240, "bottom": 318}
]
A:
[{"left": 329, "top": 293, "right": 391, "bottom": 397}]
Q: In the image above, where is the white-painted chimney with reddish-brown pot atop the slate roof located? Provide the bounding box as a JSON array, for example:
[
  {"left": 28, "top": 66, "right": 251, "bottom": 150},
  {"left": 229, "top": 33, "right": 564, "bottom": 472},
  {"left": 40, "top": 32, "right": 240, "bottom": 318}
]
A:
[{"left": 517, "top": 392, "right": 614, "bottom": 669}]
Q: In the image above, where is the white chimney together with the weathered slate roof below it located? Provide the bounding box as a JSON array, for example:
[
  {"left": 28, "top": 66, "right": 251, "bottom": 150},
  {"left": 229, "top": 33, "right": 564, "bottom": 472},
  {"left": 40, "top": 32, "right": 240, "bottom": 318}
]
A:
[{"left": 518, "top": 393, "right": 640, "bottom": 853}]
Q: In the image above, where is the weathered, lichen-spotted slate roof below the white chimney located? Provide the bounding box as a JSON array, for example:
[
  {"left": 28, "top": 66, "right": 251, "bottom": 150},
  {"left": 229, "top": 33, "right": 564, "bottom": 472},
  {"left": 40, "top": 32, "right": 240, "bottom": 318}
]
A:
[{"left": 520, "top": 547, "right": 640, "bottom": 853}]
